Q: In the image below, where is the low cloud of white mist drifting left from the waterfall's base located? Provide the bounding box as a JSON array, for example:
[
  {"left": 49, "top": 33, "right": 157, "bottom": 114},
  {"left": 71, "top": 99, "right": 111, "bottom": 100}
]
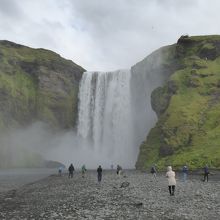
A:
[{"left": 0, "top": 122, "right": 131, "bottom": 169}]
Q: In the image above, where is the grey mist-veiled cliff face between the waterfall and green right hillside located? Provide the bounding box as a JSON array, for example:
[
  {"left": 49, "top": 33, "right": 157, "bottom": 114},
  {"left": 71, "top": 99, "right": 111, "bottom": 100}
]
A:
[{"left": 130, "top": 45, "right": 177, "bottom": 155}]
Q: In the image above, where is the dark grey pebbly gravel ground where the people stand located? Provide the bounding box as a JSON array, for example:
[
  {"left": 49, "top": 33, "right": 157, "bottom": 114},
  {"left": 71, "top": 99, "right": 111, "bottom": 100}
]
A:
[{"left": 0, "top": 171, "right": 220, "bottom": 220}]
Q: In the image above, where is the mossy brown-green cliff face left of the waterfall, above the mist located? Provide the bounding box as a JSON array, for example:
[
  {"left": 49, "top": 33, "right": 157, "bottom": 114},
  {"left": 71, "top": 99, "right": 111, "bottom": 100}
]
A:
[{"left": 0, "top": 41, "right": 85, "bottom": 130}]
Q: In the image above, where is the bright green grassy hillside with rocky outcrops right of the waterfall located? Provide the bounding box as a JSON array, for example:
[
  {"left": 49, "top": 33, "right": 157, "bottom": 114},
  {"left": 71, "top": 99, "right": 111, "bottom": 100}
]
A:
[{"left": 136, "top": 36, "right": 220, "bottom": 169}]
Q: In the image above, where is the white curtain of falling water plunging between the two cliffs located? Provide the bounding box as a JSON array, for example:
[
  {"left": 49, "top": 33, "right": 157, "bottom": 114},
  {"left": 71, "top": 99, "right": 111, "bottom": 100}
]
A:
[{"left": 77, "top": 70, "right": 137, "bottom": 168}]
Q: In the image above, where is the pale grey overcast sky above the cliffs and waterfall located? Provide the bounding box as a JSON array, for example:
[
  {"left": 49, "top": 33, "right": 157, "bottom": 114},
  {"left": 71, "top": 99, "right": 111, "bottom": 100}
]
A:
[{"left": 0, "top": 0, "right": 220, "bottom": 71}]
